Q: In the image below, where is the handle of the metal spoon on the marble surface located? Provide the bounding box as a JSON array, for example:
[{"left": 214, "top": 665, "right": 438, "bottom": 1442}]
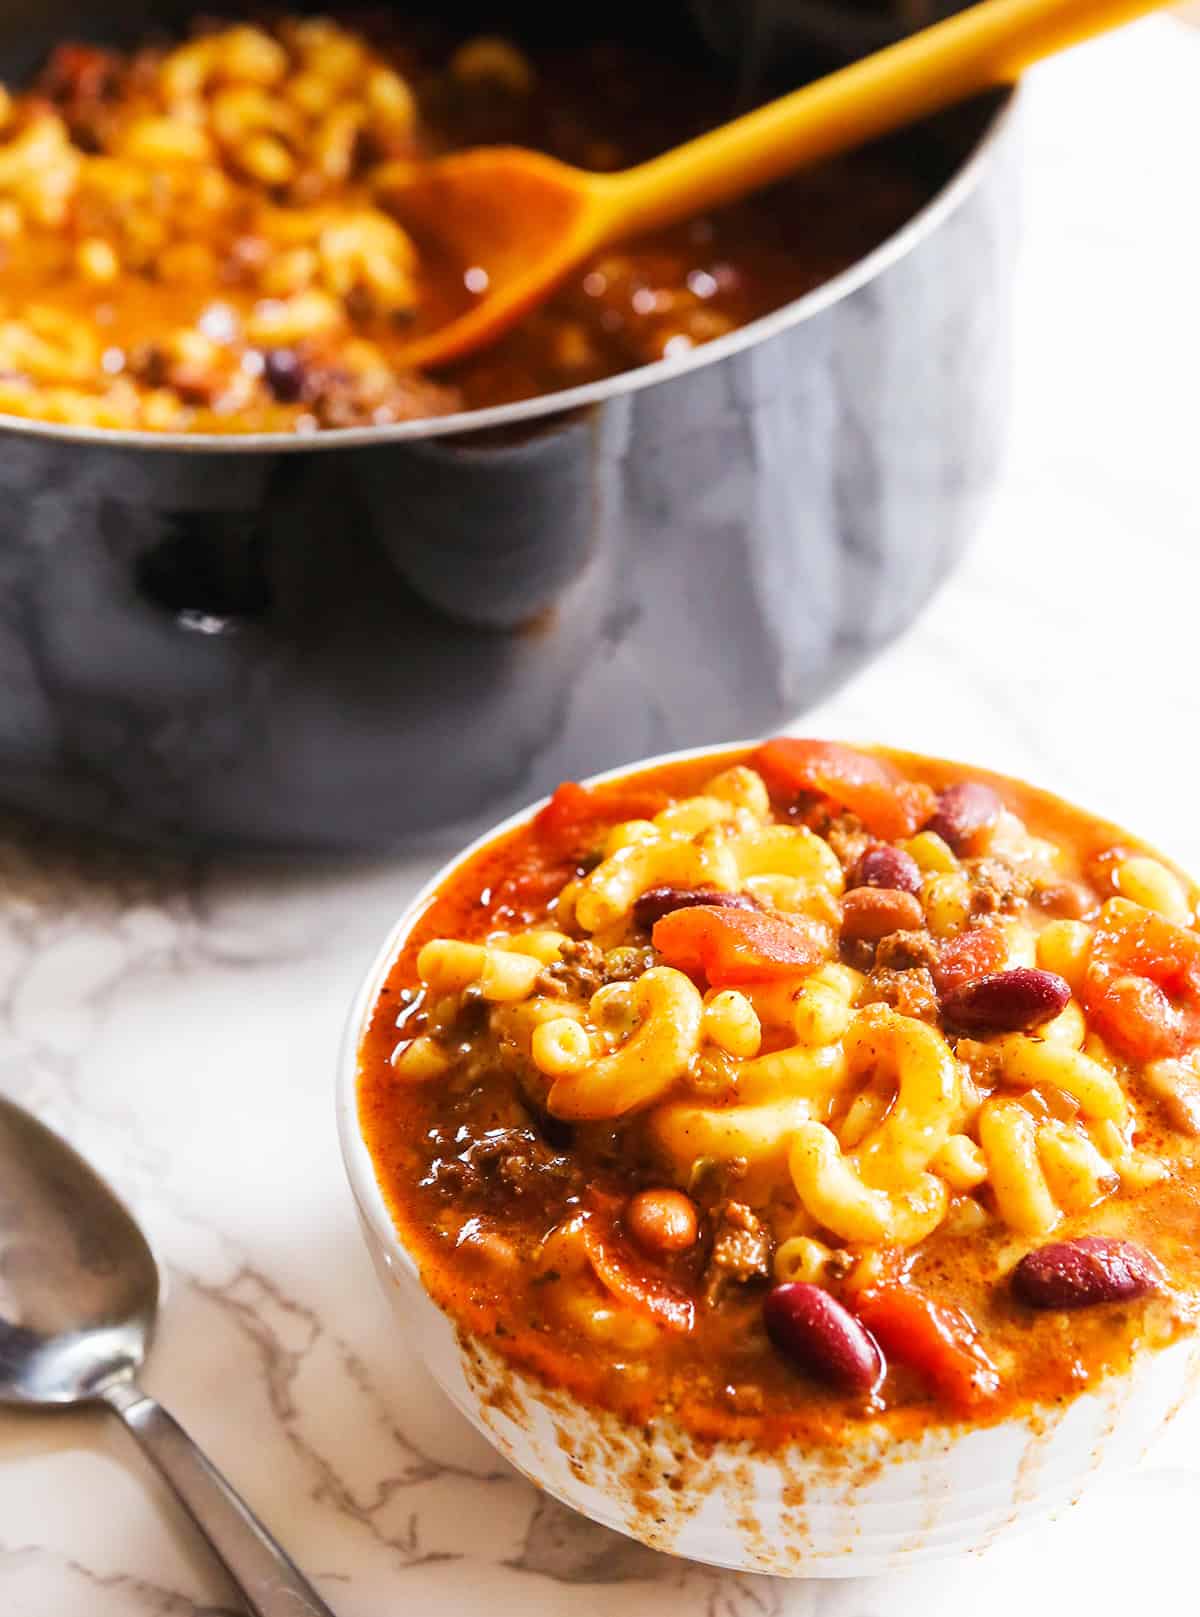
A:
[{"left": 100, "top": 1381, "right": 333, "bottom": 1617}]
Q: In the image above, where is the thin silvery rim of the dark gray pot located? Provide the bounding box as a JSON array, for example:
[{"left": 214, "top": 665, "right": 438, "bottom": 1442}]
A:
[{"left": 0, "top": 81, "right": 1024, "bottom": 454}]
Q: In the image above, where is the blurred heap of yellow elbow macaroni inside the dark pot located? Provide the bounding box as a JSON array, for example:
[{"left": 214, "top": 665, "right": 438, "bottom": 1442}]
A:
[{"left": 0, "top": 18, "right": 522, "bottom": 432}]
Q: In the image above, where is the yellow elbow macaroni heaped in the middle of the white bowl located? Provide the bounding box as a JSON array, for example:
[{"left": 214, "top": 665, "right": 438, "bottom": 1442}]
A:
[{"left": 395, "top": 753, "right": 1190, "bottom": 1261}]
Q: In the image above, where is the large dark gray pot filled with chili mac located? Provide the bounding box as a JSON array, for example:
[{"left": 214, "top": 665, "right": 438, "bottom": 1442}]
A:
[{"left": 0, "top": 0, "right": 1017, "bottom": 851}]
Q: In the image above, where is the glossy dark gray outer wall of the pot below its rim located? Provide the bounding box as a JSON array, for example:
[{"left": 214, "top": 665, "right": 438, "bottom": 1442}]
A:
[{"left": 0, "top": 97, "right": 1016, "bottom": 852}]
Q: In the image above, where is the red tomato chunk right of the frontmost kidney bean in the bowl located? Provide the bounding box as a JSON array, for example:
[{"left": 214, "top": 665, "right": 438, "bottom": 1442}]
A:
[{"left": 854, "top": 1282, "right": 999, "bottom": 1412}]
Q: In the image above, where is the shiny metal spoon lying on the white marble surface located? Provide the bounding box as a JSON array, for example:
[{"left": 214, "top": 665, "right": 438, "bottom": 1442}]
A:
[{"left": 0, "top": 1100, "right": 333, "bottom": 1617}]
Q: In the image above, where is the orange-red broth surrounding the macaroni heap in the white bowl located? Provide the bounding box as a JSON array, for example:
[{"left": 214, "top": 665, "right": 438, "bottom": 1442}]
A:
[{"left": 359, "top": 752, "right": 1200, "bottom": 1447}]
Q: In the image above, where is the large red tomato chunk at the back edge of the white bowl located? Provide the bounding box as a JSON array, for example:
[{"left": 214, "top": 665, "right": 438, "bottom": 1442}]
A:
[{"left": 754, "top": 736, "right": 936, "bottom": 842}]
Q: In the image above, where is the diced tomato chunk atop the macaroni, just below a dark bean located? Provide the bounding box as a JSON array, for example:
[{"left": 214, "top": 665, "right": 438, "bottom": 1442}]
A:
[{"left": 650, "top": 904, "right": 825, "bottom": 988}]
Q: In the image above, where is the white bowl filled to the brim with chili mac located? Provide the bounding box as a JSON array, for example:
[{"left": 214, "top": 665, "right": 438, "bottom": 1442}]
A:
[{"left": 338, "top": 737, "right": 1200, "bottom": 1577}]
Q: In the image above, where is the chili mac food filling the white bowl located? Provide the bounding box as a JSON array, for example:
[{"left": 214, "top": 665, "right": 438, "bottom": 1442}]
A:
[{"left": 372, "top": 741, "right": 1200, "bottom": 1431}]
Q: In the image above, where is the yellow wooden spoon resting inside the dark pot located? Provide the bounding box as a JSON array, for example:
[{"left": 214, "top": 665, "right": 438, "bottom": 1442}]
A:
[{"left": 380, "top": 0, "right": 1164, "bottom": 367}]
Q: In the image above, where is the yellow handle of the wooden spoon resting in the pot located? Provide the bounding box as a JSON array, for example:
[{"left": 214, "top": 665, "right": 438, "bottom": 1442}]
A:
[{"left": 595, "top": 0, "right": 1164, "bottom": 238}]
